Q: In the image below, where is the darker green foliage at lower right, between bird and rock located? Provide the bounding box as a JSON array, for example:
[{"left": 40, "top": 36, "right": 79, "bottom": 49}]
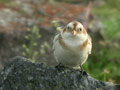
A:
[{"left": 84, "top": 47, "right": 120, "bottom": 83}]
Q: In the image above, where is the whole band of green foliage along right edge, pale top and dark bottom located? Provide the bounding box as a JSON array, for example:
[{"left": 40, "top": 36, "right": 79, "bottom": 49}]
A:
[{"left": 84, "top": 0, "right": 120, "bottom": 83}]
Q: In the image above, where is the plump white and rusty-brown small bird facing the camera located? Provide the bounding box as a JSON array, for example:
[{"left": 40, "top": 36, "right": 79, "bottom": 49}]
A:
[{"left": 53, "top": 21, "right": 92, "bottom": 69}]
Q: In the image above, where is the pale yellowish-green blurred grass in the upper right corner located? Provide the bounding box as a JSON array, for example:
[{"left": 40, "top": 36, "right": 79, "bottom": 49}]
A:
[{"left": 93, "top": 0, "right": 120, "bottom": 40}]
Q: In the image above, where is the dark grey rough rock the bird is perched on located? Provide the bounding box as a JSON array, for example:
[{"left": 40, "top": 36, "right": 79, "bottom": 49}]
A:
[{"left": 0, "top": 56, "right": 120, "bottom": 90}]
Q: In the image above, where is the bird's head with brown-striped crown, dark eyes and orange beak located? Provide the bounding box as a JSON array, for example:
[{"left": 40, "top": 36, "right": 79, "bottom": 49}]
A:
[{"left": 63, "top": 21, "right": 87, "bottom": 36}]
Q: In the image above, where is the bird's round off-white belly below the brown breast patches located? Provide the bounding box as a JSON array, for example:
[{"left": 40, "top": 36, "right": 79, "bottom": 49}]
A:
[{"left": 54, "top": 42, "right": 87, "bottom": 67}]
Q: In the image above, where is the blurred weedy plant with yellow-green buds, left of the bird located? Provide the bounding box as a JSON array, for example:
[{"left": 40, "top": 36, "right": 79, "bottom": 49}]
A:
[{"left": 22, "top": 26, "right": 50, "bottom": 62}]
